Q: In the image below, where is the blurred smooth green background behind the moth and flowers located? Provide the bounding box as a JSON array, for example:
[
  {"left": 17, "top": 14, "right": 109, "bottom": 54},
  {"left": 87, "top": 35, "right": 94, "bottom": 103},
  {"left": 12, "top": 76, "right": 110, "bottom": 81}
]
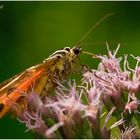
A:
[{"left": 0, "top": 1, "right": 140, "bottom": 138}]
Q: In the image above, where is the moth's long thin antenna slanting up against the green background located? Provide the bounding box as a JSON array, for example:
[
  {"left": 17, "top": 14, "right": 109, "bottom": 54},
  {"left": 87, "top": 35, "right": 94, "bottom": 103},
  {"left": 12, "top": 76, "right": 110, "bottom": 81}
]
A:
[{"left": 77, "top": 12, "right": 114, "bottom": 44}]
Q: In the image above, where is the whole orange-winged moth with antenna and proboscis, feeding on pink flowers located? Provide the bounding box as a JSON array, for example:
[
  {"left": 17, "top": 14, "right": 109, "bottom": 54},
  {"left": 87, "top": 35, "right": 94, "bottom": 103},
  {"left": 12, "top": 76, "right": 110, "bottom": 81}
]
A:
[{"left": 0, "top": 13, "right": 112, "bottom": 118}]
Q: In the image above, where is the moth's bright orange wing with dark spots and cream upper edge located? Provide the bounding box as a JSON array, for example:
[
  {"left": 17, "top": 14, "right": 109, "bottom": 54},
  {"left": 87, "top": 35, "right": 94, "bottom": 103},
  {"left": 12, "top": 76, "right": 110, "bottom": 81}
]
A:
[{"left": 0, "top": 60, "right": 55, "bottom": 118}]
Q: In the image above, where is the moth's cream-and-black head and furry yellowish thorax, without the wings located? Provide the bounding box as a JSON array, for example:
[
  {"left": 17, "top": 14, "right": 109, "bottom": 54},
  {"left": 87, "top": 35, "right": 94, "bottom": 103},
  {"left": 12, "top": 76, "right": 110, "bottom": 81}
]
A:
[{"left": 44, "top": 47, "right": 81, "bottom": 79}]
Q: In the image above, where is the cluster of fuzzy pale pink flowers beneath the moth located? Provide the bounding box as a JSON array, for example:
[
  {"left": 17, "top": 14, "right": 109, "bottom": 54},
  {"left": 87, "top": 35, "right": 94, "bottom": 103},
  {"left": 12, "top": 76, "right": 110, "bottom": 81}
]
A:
[{"left": 13, "top": 44, "right": 140, "bottom": 139}]
